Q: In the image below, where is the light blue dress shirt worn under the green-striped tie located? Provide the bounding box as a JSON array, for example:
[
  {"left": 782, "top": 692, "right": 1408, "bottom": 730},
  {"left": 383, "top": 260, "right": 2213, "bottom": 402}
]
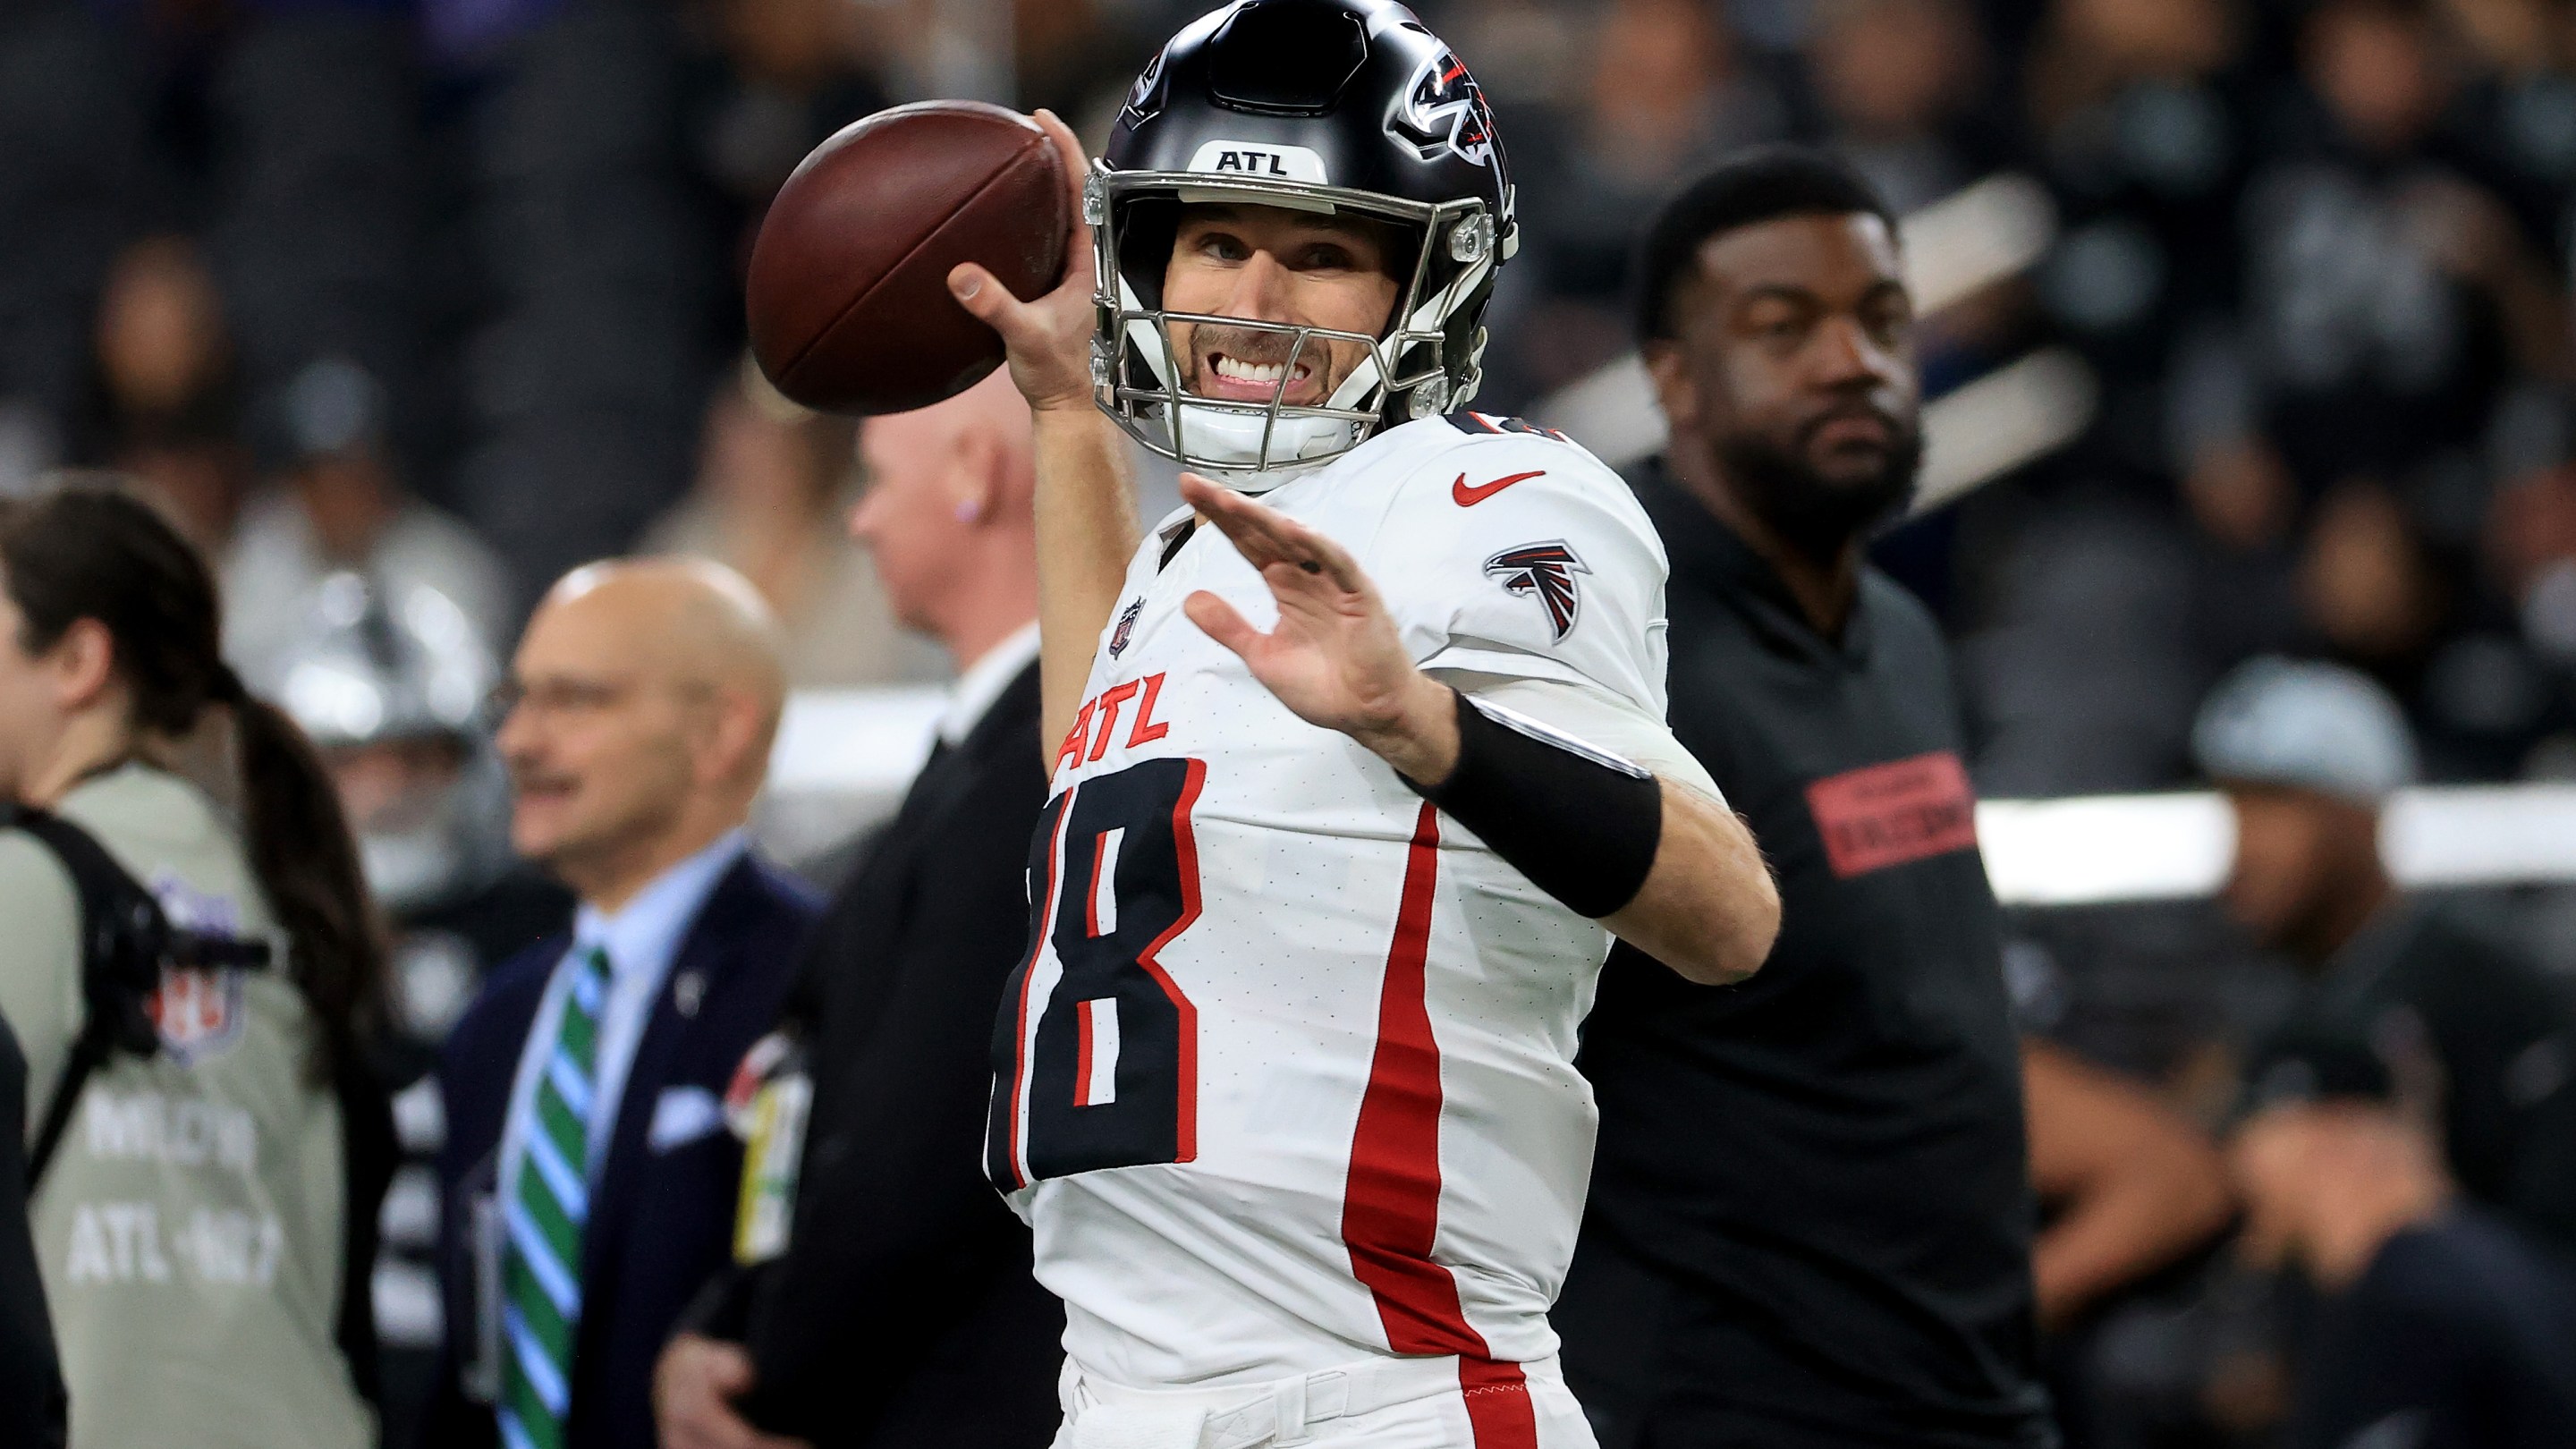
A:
[{"left": 497, "top": 830, "right": 750, "bottom": 1204}]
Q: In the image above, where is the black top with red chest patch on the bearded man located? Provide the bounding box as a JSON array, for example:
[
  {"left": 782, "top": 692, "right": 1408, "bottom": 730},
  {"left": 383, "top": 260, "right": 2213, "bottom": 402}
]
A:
[{"left": 1556, "top": 464, "right": 2055, "bottom": 1449}]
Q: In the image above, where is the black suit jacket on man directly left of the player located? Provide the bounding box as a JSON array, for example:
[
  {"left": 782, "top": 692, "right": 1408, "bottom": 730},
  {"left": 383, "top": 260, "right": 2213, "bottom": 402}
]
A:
[{"left": 703, "top": 665, "right": 1063, "bottom": 1449}]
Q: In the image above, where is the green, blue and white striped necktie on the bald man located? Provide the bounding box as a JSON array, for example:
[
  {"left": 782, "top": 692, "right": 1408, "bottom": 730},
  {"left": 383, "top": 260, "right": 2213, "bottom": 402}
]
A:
[{"left": 497, "top": 946, "right": 608, "bottom": 1449}]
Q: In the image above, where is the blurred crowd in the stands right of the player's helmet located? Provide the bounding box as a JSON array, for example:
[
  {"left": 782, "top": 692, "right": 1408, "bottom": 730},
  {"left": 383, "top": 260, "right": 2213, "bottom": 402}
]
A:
[{"left": 1450, "top": 0, "right": 2576, "bottom": 794}]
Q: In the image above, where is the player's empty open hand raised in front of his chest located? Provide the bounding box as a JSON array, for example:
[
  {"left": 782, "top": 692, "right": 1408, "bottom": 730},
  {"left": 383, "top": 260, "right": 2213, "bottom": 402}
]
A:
[{"left": 1180, "top": 472, "right": 1458, "bottom": 784}]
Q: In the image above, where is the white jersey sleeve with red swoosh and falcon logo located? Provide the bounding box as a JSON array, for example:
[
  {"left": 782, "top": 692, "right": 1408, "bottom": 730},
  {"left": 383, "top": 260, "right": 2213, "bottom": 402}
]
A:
[{"left": 1363, "top": 436, "right": 1666, "bottom": 719}]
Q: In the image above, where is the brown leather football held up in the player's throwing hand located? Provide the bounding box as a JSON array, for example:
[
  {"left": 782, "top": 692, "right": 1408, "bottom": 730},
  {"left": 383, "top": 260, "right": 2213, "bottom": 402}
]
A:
[{"left": 744, "top": 100, "right": 1074, "bottom": 412}]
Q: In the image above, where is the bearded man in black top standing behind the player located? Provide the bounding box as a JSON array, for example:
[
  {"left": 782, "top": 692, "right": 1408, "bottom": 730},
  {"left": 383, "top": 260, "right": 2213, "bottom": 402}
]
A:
[{"left": 1554, "top": 152, "right": 2055, "bottom": 1449}]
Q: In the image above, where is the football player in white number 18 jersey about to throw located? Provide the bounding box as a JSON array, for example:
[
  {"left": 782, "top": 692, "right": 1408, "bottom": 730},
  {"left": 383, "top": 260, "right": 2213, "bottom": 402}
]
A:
[{"left": 951, "top": 0, "right": 1777, "bottom": 1449}]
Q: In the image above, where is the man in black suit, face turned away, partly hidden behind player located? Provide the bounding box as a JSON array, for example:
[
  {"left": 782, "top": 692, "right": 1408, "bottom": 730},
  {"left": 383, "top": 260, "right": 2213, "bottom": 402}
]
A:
[{"left": 655, "top": 374, "right": 1063, "bottom": 1449}]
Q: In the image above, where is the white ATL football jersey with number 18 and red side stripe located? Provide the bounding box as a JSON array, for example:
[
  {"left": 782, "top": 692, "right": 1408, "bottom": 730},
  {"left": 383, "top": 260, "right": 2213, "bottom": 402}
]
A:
[{"left": 987, "top": 412, "right": 1666, "bottom": 1402}]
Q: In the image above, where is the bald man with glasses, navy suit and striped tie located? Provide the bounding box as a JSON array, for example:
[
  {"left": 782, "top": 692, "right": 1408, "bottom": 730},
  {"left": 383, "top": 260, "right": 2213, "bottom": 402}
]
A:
[{"left": 428, "top": 562, "right": 819, "bottom": 1449}]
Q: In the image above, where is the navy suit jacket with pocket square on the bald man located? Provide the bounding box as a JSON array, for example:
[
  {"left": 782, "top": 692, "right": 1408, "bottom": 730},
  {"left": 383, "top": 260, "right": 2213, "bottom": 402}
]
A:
[{"left": 422, "top": 856, "right": 819, "bottom": 1449}]
